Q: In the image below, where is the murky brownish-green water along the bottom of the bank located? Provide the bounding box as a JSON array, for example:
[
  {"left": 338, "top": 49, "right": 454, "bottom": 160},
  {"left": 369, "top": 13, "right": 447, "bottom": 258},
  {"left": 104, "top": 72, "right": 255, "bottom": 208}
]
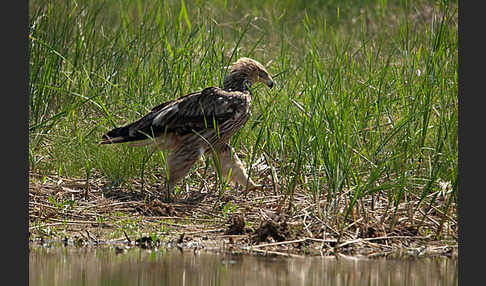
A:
[{"left": 29, "top": 247, "right": 458, "bottom": 286}]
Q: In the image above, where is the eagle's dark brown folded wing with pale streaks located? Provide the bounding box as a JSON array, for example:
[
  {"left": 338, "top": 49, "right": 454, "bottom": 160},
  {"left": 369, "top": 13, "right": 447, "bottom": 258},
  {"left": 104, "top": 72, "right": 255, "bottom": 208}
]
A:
[{"left": 101, "top": 87, "right": 249, "bottom": 144}]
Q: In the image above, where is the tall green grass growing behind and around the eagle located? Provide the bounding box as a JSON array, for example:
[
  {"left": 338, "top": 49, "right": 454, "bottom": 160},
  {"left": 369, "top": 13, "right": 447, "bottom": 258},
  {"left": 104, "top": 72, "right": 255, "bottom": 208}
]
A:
[{"left": 29, "top": 0, "right": 458, "bottom": 239}]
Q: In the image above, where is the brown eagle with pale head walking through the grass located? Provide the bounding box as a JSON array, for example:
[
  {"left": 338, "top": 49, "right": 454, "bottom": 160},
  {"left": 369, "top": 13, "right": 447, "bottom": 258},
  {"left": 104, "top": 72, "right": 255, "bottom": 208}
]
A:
[{"left": 100, "top": 57, "right": 274, "bottom": 197}]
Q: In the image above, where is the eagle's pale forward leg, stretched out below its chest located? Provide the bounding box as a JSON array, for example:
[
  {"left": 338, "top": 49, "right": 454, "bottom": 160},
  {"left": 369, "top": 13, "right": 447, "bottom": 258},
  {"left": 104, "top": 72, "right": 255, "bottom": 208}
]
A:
[{"left": 216, "top": 144, "right": 262, "bottom": 190}]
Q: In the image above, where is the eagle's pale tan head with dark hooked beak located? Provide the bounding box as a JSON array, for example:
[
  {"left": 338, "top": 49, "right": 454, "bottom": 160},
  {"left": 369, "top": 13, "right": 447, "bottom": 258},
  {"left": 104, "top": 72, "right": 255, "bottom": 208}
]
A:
[{"left": 223, "top": 58, "right": 274, "bottom": 90}]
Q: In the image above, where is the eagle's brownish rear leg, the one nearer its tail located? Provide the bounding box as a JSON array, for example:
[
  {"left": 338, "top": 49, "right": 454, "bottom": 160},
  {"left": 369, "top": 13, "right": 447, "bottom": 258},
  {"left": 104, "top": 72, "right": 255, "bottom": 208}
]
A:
[{"left": 165, "top": 145, "right": 203, "bottom": 201}]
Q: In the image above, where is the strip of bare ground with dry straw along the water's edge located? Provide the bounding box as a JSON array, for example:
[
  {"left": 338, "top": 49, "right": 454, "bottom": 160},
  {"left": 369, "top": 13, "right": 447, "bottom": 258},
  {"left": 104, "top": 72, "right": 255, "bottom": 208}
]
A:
[{"left": 29, "top": 174, "right": 457, "bottom": 257}]
